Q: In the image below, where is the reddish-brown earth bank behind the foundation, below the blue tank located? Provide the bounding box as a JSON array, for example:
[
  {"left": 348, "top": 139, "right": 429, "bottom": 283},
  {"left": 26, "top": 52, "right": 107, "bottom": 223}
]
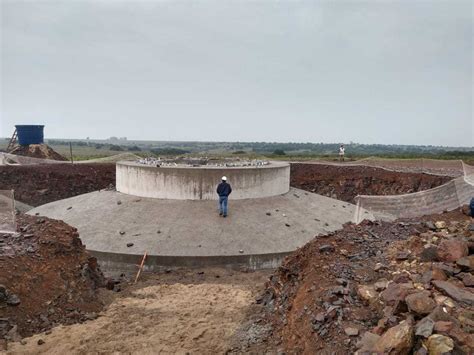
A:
[{"left": 0, "top": 164, "right": 115, "bottom": 206}]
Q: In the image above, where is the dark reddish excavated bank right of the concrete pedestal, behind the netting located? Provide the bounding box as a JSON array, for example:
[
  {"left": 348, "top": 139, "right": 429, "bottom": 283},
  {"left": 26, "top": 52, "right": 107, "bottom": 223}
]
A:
[{"left": 290, "top": 164, "right": 451, "bottom": 203}]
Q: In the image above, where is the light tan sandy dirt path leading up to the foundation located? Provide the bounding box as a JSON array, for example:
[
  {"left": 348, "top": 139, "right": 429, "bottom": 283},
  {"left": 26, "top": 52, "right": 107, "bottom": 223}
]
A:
[{"left": 7, "top": 269, "right": 268, "bottom": 354}]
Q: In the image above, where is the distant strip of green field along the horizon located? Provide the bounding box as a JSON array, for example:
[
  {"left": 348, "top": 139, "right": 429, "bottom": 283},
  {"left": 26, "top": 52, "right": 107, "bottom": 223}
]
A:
[{"left": 0, "top": 139, "right": 474, "bottom": 163}]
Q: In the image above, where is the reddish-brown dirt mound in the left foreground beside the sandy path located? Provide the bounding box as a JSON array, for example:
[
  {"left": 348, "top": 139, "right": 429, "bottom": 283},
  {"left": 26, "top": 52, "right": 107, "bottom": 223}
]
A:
[{"left": 0, "top": 215, "right": 105, "bottom": 348}]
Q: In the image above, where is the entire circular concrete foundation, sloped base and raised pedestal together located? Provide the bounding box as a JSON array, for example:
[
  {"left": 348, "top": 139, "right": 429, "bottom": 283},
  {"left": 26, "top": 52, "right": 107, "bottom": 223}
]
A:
[{"left": 29, "top": 162, "right": 371, "bottom": 272}]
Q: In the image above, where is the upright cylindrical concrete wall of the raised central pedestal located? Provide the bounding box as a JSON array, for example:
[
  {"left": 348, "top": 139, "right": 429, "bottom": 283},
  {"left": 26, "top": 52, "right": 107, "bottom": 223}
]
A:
[{"left": 116, "top": 162, "right": 290, "bottom": 200}]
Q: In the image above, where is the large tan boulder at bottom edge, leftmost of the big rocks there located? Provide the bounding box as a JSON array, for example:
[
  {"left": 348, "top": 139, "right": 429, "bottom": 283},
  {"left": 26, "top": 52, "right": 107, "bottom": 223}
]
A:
[{"left": 373, "top": 320, "right": 414, "bottom": 355}]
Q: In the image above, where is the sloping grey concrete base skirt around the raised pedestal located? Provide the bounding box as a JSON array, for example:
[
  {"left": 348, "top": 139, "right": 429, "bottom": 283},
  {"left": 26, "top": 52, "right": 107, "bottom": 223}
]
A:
[{"left": 28, "top": 188, "right": 371, "bottom": 268}]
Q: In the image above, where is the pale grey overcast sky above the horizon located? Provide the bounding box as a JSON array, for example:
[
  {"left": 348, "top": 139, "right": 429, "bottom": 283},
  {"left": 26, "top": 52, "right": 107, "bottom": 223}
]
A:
[{"left": 0, "top": 0, "right": 474, "bottom": 146}]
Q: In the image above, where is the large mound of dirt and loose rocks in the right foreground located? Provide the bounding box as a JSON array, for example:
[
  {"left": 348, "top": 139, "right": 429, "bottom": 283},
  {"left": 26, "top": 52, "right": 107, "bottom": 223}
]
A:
[{"left": 251, "top": 210, "right": 474, "bottom": 354}]
